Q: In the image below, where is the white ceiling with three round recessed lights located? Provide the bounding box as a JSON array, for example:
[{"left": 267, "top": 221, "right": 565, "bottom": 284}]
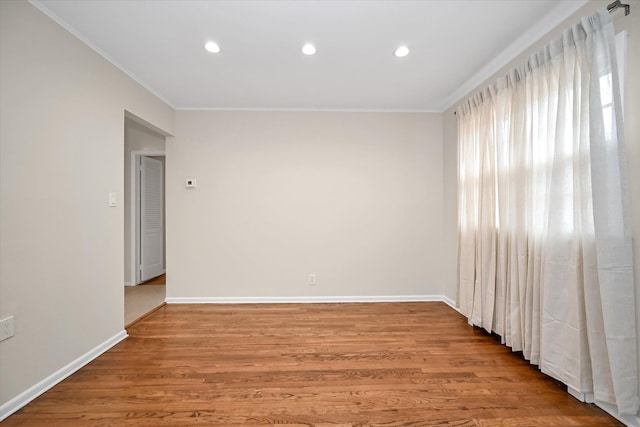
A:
[{"left": 32, "top": 0, "right": 586, "bottom": 111}]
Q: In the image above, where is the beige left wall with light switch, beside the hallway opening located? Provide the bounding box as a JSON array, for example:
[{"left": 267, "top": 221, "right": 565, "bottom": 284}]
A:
[{"left": 0, "top": 1, "right": 174, "bottom": 403}]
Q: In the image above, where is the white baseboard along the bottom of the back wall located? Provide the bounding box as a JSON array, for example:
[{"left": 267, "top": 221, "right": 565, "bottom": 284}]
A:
[{"left": 165, "top": 295, "right": 457, "bottom": 310}]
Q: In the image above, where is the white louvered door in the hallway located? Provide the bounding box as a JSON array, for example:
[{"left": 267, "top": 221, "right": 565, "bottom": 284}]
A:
[{"left": 140, "top": 157, "right": 164, "bottom": 282}]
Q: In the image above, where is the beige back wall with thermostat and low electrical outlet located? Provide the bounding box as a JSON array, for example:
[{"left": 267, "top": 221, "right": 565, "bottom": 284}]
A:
[{"left": 166, "top": 111, "right": 443, "bottom": 298}]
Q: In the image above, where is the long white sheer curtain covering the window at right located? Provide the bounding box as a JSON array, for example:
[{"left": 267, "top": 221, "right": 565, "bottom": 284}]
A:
[{"left": 457, "top": 10, "right": 640, "bottom": 415}]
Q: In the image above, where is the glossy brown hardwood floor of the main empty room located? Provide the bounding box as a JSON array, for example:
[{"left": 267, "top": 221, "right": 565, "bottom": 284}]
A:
[{"left": 3, "top": 302, "right": 620, "bottom": 427}]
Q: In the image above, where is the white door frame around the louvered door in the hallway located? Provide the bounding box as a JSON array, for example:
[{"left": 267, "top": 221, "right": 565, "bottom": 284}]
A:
[{"left": 129, "top": 150, "right": 167, "bottom": 286}]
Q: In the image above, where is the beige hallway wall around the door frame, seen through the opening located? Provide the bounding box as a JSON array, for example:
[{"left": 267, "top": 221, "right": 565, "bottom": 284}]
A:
[{"left": 123, "top": 119, "right": 165, "bottom": 285}]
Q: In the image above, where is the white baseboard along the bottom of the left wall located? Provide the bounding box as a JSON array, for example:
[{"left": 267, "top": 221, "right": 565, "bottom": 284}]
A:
[{"left": 0, "top": 330, "right": 128, "bottom": 422}]
